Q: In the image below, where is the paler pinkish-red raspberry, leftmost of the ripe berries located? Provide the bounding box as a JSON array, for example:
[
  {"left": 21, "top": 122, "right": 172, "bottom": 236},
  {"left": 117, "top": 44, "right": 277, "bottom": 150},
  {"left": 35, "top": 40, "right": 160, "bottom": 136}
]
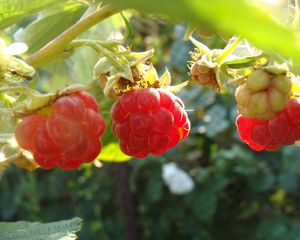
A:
[{"left": 15, "top": 92, "right": 106, "bottom": 170}]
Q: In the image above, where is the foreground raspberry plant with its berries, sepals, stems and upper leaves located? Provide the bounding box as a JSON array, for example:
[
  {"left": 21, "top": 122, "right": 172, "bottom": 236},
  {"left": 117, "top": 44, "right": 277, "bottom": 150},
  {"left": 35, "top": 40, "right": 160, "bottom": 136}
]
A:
[{"left": 0, "top": 0, "right": 300, "bottom": 238}]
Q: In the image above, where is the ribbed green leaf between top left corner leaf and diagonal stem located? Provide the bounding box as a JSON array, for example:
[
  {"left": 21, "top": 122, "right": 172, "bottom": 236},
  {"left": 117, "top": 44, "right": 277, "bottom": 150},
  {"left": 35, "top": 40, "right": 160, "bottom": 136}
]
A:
[{"left": 17, "top": 2, "right": 88, "bottom": 53}]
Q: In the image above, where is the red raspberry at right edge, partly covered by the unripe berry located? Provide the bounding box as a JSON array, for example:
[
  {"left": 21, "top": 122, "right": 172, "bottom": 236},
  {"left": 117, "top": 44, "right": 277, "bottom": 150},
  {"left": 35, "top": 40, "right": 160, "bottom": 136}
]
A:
[{"left": 236, "top": 98, "right": 300, "bottom": 151}]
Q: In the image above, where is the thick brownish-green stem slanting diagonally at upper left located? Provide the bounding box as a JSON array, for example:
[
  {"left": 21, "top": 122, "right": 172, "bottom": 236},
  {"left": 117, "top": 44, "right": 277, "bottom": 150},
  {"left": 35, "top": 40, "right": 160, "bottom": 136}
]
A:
[{"left": 26, "top": 5, "right": 120, "bottom": 67}]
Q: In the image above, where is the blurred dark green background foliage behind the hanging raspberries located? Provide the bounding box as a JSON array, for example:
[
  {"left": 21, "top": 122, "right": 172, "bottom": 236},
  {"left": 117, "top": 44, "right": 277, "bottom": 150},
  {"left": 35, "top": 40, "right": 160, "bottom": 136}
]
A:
[{"left": 0, "top": 0, "right": 300, "bottom": 240}]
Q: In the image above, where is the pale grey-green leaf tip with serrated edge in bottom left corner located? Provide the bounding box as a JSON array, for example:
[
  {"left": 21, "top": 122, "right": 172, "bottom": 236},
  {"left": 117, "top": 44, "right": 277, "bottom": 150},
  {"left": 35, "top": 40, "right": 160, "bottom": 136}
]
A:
[{"left": 0, "top": 217, "right": 82, "bottom": 240}]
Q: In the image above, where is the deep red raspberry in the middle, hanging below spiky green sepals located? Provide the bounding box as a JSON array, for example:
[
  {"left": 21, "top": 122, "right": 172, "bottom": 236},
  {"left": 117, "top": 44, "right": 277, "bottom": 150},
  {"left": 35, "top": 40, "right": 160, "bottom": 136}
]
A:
[{"left": 111, "top": 88, "right": 190, "bottom": 158}]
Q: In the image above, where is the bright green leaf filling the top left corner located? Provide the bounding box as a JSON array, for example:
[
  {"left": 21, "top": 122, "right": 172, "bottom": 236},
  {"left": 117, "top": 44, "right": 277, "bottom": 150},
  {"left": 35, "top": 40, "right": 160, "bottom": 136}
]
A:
[{"left": 0, "top": 0, "right": 66, "bottom": 30}]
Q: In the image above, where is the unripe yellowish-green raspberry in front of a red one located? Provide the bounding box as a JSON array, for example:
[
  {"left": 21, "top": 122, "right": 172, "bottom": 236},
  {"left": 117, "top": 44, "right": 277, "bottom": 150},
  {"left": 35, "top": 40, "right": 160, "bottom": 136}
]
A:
[{"left": 235, "top": 70, "right": 291, "bottom": 119}]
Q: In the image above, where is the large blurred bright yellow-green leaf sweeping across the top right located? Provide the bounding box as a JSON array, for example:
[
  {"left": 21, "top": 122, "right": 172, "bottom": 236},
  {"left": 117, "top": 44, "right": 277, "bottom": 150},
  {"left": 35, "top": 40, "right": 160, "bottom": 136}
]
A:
[{"left": 110, "top": 0, "right": 300, "bottom": 71}]
